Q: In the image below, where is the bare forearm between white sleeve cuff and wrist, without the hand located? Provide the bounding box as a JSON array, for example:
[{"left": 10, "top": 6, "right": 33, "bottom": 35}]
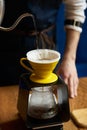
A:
[{"left": 63, "top": 29, "right": 80, "bottom": 61}]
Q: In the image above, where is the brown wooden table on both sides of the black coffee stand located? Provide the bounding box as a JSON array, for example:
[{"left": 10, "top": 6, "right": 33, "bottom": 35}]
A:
[{"left": 0, "top": 78, "right": 87, "bottom": 130}]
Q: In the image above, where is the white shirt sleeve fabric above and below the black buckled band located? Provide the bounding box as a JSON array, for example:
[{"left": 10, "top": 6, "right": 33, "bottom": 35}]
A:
[{"left": 63, "top": 0, "right": 87, "bottom": 32}]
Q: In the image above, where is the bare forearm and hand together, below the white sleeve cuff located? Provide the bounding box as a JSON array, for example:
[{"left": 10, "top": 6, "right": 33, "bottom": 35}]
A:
[{"left": 58, "top": 29, "right": 80, "bottom": 98}]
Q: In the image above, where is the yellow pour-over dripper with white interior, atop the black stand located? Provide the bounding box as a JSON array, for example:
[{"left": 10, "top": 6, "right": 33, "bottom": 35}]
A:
[{"left": 20, "top": 49, "right": 60, "bottom": 83}]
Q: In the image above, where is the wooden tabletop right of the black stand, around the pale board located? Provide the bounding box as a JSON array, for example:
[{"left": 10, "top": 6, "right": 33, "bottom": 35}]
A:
[{"left": 64, "top": 78, "right": 87, "bottom": 130}]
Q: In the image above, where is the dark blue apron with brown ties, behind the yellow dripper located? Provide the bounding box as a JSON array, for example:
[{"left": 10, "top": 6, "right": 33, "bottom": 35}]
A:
[{"left": 25, "top": 0, "right": 61, "bottom": 52}]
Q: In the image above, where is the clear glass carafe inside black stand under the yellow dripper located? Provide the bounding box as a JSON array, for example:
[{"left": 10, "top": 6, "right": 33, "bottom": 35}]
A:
[{"left": 28, "top": 86, "right": 57, "bottom": 119}]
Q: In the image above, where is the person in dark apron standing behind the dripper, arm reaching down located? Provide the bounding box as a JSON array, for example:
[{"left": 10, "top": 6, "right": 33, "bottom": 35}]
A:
[{"left": 2, "top": 0, "right": 86, "bottom": 98}]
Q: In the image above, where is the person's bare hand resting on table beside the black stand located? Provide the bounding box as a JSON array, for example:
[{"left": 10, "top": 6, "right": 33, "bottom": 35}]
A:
[{"left": 57, "top": 59, "right": 79, "bottom": 98}]
